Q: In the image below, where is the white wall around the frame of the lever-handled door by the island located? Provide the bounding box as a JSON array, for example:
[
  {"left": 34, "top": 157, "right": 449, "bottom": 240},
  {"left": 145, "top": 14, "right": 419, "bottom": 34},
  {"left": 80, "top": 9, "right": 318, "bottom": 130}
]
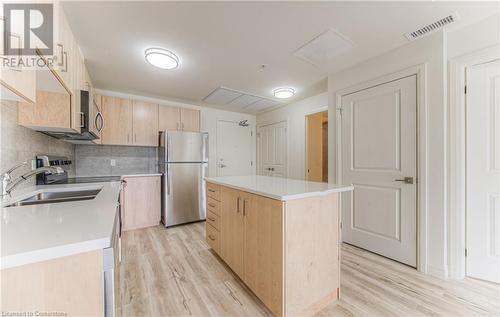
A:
[{"left": 328, "top": 31, "right": 446, "bottom": 277}]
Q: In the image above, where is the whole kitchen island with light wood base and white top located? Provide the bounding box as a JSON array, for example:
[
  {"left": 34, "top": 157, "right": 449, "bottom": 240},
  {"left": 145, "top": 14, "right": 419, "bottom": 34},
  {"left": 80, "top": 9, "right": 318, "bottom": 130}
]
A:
[{"left": 205, "top": 176, "right": 353, "bottom": 316}]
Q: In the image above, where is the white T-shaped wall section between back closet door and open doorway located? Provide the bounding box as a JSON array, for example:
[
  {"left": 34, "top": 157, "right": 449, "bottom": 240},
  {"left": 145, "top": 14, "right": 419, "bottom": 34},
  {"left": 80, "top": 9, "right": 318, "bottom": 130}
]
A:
[{"left": 257, "top": 92, "right": 328, "bottom": 179}]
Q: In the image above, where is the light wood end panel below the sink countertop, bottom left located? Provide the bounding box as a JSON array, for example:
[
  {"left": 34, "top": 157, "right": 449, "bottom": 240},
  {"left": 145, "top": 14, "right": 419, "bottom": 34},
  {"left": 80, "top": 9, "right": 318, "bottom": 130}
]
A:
[{"left": 0, "top": 250, "right": 104, "bottom": 316}]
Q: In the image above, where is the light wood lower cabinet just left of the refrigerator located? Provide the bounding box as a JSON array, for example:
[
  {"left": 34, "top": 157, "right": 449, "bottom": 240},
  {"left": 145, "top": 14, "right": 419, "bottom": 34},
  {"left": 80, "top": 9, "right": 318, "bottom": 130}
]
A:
[{"left": 122, "top": 176, "right": 161, "bottom": 231}]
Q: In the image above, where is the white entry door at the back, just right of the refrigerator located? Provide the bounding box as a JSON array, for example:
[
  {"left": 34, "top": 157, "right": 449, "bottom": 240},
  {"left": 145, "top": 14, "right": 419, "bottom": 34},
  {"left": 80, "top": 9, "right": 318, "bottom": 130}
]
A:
[{"left": 217, "top": 120, "right": 254, "bottom": 176}]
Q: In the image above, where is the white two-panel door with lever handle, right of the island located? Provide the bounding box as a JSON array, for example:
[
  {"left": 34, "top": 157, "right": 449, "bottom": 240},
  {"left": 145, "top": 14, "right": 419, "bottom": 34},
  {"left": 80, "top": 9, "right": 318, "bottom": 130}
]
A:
[{"left": 341, "top": 76, "right": 417, "bottom": 267}]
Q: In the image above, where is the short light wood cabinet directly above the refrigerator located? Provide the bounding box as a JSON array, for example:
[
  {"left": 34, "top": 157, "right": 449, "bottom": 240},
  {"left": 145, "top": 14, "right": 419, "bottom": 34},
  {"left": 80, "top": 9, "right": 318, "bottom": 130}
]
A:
[{"left": 158, "top": 105, "right": 200, "bottom": 132}]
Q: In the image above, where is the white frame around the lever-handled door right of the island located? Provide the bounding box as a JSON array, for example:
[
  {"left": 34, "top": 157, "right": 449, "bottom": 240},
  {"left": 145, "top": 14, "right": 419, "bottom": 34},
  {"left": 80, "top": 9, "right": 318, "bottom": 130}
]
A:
[{"left": 328, "top": 63, "right": 428, "bottom": 273}]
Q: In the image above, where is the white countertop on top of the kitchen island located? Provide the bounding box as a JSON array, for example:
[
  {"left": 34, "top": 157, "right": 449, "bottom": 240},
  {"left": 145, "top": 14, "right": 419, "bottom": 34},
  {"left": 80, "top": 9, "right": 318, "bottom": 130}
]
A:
[{"left": 205, "top": 175, "right": 354, "bottom": 201}]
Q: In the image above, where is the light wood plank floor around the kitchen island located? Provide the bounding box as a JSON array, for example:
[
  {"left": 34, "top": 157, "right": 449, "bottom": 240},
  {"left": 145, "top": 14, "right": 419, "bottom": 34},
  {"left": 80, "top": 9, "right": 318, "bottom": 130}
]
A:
[{"left": 120, "top": 223, "right": 500, "bottom": 317}]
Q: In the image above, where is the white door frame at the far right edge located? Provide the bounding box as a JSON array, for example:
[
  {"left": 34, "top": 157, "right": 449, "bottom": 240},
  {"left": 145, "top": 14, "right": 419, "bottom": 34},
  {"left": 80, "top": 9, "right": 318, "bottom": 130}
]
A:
[{"left": 447, "top": 44, "right": 500, "bottom": 279}]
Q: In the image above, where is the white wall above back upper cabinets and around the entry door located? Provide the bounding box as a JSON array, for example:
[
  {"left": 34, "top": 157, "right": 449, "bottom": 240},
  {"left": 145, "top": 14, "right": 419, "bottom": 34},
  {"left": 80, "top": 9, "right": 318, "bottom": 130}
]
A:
[{"left": 96, "top": 89, "right": 256, "bottom": 176}]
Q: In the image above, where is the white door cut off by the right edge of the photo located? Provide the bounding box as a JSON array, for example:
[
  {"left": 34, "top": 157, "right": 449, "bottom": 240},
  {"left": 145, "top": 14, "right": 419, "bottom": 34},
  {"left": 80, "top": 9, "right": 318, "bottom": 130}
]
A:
[{"left": 466, "top": 60, "right": 500, "bottom": 283}]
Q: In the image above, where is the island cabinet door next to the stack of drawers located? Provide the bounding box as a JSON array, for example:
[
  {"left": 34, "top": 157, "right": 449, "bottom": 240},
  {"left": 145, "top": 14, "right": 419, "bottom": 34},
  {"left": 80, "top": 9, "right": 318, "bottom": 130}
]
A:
[{"left": 220, "top": 186, "right": 245, "bottom": 278}]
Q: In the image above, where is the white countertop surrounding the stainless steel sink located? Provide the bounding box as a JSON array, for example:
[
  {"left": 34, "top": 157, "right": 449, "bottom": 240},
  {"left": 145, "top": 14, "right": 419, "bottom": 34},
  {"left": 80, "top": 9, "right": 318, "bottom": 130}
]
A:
[{"left": 0, "top": 182, "right": 120, "bottom": 269}]
